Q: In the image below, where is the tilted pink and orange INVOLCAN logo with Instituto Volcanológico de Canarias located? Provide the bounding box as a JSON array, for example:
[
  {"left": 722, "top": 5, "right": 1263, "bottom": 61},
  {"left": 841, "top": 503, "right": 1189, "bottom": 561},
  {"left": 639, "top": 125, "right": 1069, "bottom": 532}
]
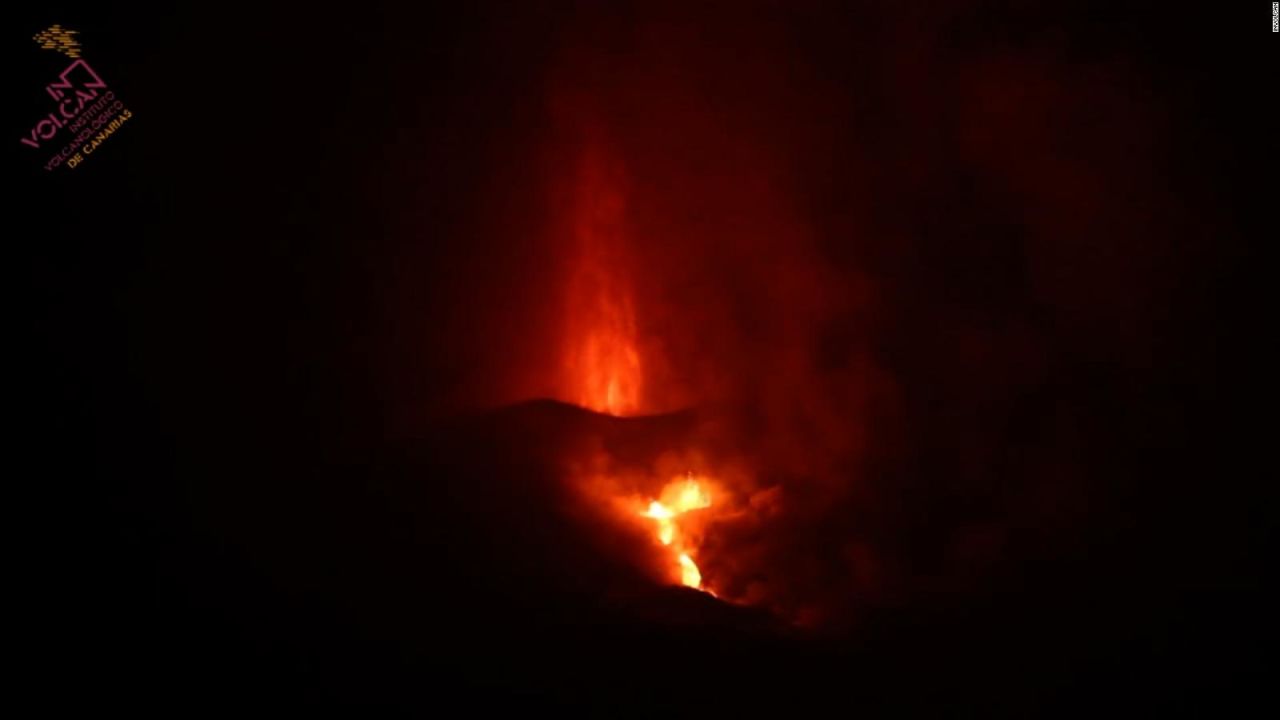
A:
[{"left": 18, "top": 26, "right": 133, "bottom": 172}]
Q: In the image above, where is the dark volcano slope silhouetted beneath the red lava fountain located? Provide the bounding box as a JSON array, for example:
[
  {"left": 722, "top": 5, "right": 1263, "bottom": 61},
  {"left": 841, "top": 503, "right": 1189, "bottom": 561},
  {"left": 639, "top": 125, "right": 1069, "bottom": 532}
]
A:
[{"left": 117, "top": 402, "right": 1226, "bottom": 715}]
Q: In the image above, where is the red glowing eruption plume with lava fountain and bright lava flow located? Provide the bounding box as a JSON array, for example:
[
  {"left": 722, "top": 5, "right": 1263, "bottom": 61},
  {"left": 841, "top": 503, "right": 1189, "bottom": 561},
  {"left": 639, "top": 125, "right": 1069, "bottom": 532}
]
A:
[{"left": 547, "top": 30, "right": 863, "bottom": 607}]
